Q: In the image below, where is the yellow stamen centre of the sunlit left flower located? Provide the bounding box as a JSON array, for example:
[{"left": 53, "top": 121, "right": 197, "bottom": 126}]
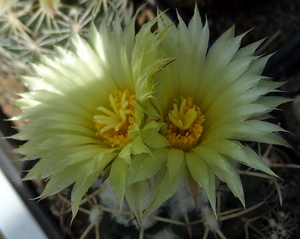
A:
[{"left": 94, "top": 90, "right": 135, "bottom": 147}]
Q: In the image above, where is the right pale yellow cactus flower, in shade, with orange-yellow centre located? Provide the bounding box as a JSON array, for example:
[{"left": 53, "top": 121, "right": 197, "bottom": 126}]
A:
[{"left": 132, "top": 10, "right": 288, "bottom": 216}]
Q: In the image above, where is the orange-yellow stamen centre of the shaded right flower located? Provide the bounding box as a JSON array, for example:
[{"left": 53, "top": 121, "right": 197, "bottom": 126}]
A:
[{"left": 166, "top": 97, "right": 205, "bottom": 151}]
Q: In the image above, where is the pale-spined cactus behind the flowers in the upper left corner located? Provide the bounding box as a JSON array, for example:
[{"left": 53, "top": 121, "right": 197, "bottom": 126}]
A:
[{"left": 0, "top": 0, "right": 133, "bottom": 74}]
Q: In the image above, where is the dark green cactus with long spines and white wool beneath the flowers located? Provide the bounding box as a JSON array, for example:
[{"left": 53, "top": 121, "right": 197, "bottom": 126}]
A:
[{"left": 31, "top": 145, "right": 300, "bottom": 239}]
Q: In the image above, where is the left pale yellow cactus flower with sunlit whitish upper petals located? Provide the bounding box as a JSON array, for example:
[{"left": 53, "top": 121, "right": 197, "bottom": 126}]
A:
[{"left": 13, "top": 14, "right": 169, "bottom": 218}]
